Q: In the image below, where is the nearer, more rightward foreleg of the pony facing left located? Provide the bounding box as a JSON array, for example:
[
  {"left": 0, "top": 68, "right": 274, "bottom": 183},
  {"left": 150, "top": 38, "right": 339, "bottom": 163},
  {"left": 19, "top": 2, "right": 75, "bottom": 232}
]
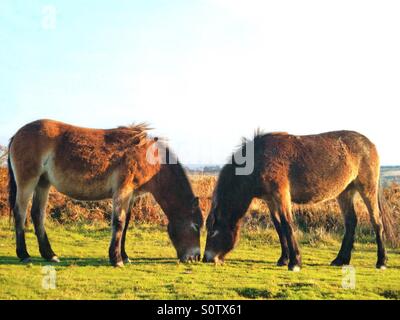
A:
[{"left": 274, "top": 191, "right": 301, "bottom": 271}]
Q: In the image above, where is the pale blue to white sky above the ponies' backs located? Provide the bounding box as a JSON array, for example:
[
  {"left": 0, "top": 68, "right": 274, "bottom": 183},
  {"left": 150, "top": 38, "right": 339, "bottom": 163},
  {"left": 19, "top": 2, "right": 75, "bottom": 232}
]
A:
[{"left": 0, "top": 0, "right": 400, "bottom": 164}]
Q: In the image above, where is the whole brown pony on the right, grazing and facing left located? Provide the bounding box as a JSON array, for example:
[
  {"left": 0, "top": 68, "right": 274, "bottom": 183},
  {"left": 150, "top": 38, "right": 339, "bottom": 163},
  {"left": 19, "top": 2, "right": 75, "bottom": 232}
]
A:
[{"left": 204, "top": 131, "right": 395, "bottom": 271}]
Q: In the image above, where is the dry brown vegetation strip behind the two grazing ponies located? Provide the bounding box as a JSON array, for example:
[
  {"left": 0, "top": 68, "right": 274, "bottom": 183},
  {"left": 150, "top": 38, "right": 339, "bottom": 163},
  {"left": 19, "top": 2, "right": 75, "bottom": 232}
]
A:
[{"left": 0, "top": 168, "right": 400, "bottom": 232}]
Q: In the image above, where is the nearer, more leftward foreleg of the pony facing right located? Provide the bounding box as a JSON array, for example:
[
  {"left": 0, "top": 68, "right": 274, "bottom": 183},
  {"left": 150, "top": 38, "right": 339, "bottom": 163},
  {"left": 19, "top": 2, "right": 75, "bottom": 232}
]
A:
[{"left": 108, "top": 190, "right": 131, "bottom": 267}]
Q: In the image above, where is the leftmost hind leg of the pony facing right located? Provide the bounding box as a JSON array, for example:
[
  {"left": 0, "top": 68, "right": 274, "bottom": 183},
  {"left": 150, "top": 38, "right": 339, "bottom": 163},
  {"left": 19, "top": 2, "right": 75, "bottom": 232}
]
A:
[{"left": 13, "top": 181, "right": 33, "bottom": 263}]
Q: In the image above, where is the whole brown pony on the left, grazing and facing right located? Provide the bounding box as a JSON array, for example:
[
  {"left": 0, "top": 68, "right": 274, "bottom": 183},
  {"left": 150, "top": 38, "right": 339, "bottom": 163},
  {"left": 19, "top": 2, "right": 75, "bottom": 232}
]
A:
[{"left": 8, "top": 120, "right": 203, "bottom": 266}]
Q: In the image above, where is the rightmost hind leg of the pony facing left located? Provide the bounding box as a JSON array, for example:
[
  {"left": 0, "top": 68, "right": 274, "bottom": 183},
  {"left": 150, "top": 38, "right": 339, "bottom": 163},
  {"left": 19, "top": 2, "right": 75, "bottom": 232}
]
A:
[{"left": 360, "top": 187, "right": 387, "bottom": 269}]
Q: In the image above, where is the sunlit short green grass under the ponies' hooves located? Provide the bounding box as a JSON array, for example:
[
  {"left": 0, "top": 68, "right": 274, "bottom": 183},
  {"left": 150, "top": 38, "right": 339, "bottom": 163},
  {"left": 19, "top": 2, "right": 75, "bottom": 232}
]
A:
[{"left": 0, "top": 219, "right": 400, "bottom": 299}]
